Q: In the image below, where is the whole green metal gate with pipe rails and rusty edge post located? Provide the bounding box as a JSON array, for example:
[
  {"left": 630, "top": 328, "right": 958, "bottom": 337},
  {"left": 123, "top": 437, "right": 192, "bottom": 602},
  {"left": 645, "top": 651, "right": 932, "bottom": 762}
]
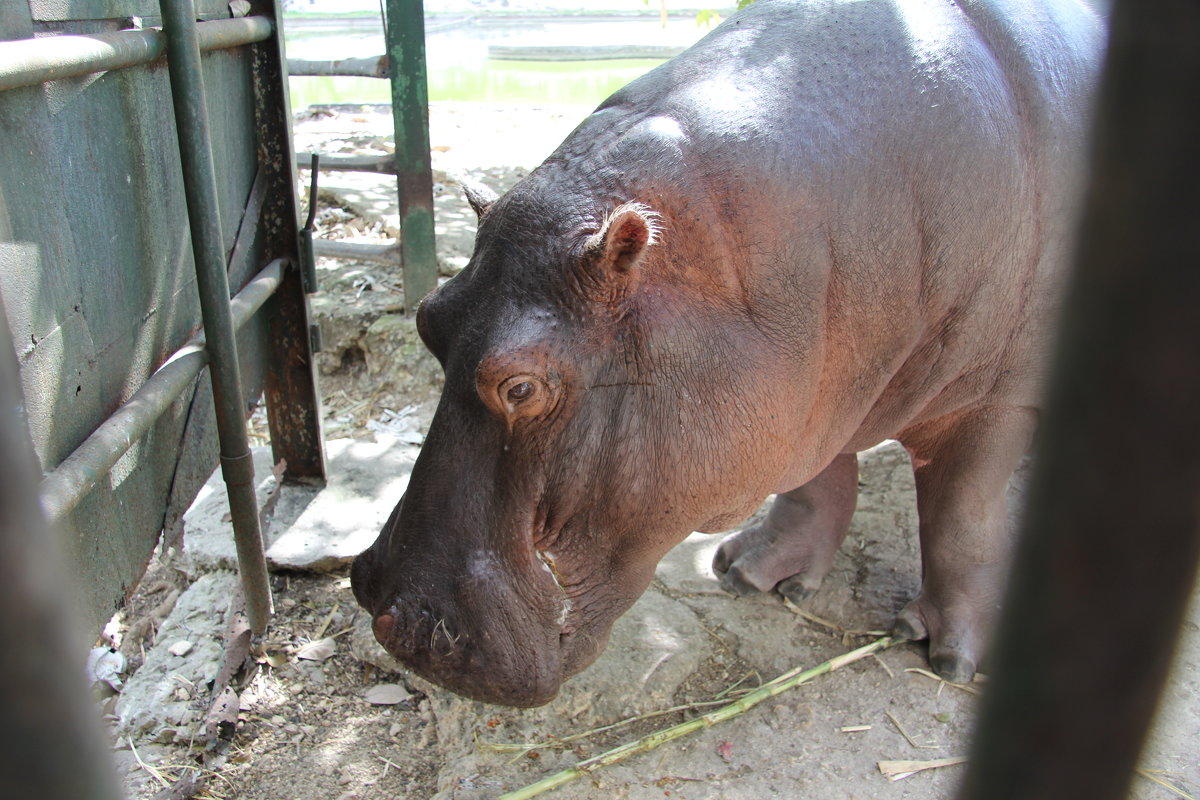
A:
[{"left": 0, "top": 0, "right": 325, "bottom": 628}]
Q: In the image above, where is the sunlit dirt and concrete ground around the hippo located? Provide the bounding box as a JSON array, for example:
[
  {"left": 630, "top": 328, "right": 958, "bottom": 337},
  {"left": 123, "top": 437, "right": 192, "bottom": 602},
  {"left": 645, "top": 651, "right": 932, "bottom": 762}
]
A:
[{"left": 102, "top": 106, "right": 1200, "bottom": 800}]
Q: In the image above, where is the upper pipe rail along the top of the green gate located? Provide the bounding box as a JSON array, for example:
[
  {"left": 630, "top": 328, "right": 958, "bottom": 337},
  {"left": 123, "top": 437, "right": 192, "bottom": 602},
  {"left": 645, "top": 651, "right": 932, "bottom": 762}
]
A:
[{"left": 0, "top": 17, "right": 272, "bottom": 91}]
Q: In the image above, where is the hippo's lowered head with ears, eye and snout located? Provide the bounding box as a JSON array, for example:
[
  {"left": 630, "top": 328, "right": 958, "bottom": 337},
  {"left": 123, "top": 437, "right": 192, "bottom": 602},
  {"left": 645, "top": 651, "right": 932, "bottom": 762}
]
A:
[{"left": 352, "top": 173, "right": 782, "bottom": 706}]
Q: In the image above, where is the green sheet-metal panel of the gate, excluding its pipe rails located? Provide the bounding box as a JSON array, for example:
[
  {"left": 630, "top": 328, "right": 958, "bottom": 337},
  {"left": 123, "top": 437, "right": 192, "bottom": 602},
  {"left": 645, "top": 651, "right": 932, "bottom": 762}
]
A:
[{"left": 0, "top": 0, "right": 324, "bottom": 638}]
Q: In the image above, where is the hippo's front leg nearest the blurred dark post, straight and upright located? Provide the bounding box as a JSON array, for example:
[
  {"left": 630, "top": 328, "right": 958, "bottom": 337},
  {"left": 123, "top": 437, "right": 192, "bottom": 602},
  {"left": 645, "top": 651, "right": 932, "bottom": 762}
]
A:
[{"left": 895, "top": 408, "right": 1037, "bottom": 682}]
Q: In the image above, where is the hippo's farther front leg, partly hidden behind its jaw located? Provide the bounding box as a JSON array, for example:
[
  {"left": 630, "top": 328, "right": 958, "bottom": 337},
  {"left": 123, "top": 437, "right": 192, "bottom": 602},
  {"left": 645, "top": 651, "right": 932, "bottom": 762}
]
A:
[{"left": 713, "top": 453, "right": 858, "bottom": 603}]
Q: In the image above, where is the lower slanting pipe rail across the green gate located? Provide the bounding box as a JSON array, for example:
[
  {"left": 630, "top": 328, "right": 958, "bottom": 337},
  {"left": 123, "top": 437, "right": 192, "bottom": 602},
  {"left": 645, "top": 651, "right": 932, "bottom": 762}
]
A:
[{"left": 38, "top": 259, "right": 284, "bottom": 522}]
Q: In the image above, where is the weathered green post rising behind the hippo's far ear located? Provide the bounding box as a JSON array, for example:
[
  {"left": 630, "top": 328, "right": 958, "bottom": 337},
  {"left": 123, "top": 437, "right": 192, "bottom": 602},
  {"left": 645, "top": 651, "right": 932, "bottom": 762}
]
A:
[{"left": 385, "top": 0, "right": 438, "bottom": 313}]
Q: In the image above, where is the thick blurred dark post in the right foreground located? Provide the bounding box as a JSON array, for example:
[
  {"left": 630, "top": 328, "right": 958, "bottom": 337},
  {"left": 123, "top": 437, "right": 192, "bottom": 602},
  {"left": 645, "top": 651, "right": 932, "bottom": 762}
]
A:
[{"left": 960, "top": 0, "right": 1200, "bottom": 800}]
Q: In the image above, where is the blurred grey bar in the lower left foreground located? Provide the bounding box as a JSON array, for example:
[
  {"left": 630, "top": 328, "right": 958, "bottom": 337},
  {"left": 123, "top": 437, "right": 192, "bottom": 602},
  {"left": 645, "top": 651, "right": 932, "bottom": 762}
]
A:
[{"left": 0, "top": 298, "right": 121, "bottom": 800}]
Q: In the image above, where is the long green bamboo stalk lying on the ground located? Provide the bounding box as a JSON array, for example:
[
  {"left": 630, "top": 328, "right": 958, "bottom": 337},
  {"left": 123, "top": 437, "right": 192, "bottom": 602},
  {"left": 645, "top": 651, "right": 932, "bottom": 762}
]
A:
[{"left": 499, "top": 636, "right": 896, "bottom": 800}]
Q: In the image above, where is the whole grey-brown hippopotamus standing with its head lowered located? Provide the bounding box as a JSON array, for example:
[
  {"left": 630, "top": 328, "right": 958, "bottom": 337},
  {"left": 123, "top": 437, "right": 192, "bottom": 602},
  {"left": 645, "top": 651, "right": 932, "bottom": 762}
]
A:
[{"left": 352, "top": 0, "right": 1104, "bottom": 706}]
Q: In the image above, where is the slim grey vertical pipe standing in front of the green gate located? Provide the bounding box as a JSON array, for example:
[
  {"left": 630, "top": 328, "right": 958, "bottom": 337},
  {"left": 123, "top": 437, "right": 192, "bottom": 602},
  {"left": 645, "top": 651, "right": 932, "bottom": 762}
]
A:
[{"left": 160, "top": 0, "right": 271, "bottom": 636}]
